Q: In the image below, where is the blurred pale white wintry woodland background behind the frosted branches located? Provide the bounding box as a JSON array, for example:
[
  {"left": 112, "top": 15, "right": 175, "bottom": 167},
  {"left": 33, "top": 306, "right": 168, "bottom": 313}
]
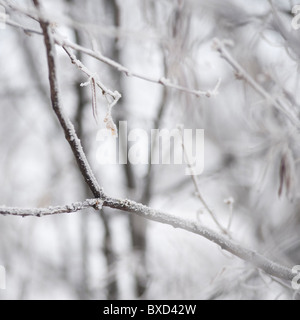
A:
[{"left": 0, "top": 0, "right": 300, "bottom": 299}]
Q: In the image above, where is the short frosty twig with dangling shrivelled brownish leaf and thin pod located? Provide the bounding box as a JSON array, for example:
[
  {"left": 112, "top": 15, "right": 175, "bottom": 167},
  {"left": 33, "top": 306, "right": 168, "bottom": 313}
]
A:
[{"left": 63, "top": 46, "right": 121, "bottom": 136}]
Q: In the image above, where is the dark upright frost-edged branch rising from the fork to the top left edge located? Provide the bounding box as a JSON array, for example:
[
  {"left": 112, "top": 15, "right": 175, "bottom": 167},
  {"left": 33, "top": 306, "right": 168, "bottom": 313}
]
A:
[{"left": 33, "top": 0, "right": 103, "bottom": 198}]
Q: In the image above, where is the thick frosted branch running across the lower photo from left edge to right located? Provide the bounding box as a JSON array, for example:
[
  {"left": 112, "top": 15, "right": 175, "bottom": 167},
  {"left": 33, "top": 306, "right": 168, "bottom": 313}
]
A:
[{"left": 0, "top": 195, "right": 295, "bottom": 281}]
